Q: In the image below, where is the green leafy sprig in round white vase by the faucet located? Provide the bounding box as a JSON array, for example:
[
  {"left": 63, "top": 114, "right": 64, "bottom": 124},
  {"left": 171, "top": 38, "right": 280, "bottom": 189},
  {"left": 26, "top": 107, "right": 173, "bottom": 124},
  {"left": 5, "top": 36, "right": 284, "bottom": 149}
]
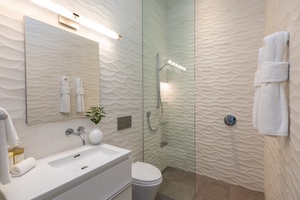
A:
[{"left": 85, "top": 106, "right": 106, "bottom": 144}]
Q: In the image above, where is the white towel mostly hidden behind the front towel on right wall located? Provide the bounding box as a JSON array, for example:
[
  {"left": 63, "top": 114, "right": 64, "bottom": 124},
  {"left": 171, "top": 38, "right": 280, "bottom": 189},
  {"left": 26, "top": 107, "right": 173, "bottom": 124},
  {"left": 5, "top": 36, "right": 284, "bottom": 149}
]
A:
[{"left": 252, "top": 47, "right": 264, "bottom": 128}]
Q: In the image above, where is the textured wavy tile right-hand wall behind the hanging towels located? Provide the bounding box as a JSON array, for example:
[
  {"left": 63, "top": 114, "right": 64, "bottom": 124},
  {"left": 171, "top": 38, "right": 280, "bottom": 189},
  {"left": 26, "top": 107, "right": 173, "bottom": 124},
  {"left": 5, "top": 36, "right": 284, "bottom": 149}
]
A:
[{"left": 265, "top": 0, "right": 300, "bottom": 200}]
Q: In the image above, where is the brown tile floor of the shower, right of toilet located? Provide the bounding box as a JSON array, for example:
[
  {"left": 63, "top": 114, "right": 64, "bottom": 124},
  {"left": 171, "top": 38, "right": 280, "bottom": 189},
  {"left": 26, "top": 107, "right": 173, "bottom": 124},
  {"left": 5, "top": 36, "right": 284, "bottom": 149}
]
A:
[{"left": 155, "top": 167, "right": 265, "bottom": 200}]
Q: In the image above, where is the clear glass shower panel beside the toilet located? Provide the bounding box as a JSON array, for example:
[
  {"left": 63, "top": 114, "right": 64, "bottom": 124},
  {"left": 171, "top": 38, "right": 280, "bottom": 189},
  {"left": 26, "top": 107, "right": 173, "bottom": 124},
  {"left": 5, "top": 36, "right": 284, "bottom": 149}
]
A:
[{"left": 143, "top": 0, "right": 195, "bottom": 199}]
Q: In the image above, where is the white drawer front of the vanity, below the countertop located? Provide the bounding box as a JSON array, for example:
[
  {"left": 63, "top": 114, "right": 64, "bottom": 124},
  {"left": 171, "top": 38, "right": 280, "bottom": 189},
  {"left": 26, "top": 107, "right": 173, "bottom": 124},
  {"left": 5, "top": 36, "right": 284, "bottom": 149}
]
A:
[{"left": 53, "top": 159, "right": 132, "bottom": 200}]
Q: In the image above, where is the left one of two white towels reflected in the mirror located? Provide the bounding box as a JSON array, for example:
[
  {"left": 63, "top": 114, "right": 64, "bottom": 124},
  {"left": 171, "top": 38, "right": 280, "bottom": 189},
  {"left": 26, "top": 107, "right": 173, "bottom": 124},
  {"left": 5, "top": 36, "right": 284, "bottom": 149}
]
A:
[{"left": 60, "top": 76, "right": 71, "bottom": 113}]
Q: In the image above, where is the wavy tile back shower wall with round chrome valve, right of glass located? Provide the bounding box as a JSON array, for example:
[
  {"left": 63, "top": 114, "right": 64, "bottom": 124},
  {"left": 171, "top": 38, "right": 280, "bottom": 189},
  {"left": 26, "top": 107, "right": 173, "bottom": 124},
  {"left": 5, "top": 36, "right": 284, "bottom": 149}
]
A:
[{"left": 195, "top": 0, "right": 264, "bottom": 191}]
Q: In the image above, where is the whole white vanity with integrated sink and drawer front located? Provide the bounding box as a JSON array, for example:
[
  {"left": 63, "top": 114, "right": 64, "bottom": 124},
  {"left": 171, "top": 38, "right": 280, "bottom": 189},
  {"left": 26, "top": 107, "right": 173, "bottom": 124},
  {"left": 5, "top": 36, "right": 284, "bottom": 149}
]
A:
[{"left": 0, "top": 144, "right": 132, "bottom": 200}]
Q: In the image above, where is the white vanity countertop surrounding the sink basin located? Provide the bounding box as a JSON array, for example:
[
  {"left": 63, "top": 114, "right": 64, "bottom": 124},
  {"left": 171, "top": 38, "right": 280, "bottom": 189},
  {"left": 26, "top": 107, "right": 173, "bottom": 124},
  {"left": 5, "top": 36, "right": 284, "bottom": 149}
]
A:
[{"left": 0, "top": 144, "right": 131, "bottom": 200}]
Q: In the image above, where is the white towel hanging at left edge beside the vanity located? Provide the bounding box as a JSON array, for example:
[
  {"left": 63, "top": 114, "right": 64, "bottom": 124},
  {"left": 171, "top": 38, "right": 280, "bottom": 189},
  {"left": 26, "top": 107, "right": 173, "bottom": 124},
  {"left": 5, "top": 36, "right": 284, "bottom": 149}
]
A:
[{"left": 0, "top": 107, "right": 19, "bottom": 185}]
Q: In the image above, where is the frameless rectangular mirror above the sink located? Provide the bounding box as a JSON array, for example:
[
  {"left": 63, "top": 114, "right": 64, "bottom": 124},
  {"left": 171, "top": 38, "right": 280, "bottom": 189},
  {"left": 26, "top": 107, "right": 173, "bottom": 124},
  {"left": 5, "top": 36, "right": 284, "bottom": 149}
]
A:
[{"left": 24, "top": 16, "right": 100, "bottom": 123}]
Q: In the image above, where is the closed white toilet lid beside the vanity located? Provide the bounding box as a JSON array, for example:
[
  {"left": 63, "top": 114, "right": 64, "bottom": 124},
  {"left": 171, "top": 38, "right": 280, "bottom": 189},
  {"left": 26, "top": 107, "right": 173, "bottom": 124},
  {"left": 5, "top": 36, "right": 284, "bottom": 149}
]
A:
[{"left": 132, "top": 162, "right": 161, "bottom": 182}]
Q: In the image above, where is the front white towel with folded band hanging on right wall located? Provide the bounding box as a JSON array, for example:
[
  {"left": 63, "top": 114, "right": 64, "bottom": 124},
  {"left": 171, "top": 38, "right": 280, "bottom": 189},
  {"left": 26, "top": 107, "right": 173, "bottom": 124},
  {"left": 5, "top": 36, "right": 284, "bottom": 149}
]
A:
[{"left": 258, "top": 32, "right": 289, "bottom": 136}]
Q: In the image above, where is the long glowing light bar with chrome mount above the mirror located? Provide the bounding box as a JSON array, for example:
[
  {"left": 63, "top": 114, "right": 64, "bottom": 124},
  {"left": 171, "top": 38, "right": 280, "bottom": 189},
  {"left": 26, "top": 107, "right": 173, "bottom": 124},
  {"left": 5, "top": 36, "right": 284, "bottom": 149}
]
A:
[{"left": 31, "top": 0, "right": 122, "bottom": 40}]
